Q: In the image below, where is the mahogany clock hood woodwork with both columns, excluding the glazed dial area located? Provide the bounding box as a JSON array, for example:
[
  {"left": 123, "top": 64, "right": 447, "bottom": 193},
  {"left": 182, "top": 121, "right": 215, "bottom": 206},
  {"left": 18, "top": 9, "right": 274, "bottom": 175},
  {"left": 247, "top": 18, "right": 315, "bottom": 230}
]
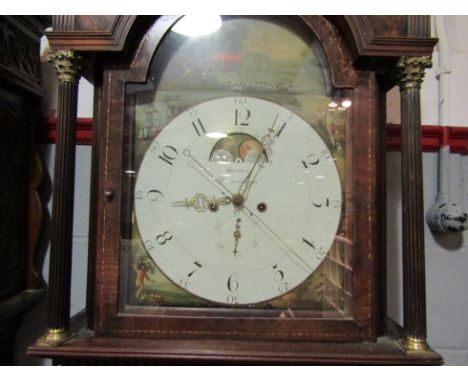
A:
[{"left": 29, "top": 16, "right": 441, "bottom": 364}]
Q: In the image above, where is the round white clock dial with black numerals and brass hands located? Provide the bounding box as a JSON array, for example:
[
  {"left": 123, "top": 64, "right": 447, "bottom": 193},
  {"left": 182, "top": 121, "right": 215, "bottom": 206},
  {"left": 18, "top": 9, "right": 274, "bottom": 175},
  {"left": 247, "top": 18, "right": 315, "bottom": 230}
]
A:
[{"left": 135, "top": 97, "right": 342, "bottom": 304}]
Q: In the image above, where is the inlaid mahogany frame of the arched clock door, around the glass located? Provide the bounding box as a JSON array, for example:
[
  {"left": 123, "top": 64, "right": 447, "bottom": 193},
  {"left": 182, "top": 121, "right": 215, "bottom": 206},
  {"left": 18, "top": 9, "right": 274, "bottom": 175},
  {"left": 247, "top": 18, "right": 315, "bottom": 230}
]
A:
[{"left": 89, "top": 17, "right": 383, "bottom": 341}]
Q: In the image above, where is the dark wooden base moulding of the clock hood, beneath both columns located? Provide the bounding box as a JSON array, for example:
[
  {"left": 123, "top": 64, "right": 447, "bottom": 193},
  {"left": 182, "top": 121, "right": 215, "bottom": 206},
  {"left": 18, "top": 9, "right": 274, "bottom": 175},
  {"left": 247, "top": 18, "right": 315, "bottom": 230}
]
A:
[{"left": 28, "top": 322, "right": 442, "bottom": 365}]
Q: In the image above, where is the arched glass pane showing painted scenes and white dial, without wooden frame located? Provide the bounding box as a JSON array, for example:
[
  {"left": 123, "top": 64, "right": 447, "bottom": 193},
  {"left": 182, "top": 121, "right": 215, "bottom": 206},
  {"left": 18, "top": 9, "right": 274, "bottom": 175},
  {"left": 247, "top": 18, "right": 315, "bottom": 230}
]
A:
[{"left": 120, "top": 17, "right": 352, "bottom": 318}]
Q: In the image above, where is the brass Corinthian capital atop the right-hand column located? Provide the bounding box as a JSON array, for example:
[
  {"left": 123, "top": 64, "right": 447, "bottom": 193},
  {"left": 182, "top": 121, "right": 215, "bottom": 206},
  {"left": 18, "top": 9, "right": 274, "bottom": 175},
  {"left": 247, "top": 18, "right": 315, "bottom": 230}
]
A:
[{"left": 396, "top": 56, "right": 432, "bottom": 91}]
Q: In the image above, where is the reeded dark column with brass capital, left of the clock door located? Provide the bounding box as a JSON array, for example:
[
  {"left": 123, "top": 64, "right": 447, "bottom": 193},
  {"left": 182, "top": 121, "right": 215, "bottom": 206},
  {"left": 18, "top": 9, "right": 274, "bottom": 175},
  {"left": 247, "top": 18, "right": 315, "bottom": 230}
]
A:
[{"left": 42, "top": 50, "right": 82, "bottom": 345}]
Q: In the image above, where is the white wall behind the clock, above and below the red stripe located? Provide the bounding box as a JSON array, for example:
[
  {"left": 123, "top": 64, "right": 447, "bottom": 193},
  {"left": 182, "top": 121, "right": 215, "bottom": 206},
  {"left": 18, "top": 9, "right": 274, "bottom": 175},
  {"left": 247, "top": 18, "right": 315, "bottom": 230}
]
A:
[{"left": 12, "top": 16, "right": 468, "bottom": 365}]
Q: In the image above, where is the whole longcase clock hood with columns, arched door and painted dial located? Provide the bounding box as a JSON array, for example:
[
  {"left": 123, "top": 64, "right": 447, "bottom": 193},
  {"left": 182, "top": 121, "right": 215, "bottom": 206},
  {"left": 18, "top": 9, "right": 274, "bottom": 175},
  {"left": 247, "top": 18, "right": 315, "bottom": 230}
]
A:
[{"left": 30, "top": 16, "right": 441, "bottom": 364}]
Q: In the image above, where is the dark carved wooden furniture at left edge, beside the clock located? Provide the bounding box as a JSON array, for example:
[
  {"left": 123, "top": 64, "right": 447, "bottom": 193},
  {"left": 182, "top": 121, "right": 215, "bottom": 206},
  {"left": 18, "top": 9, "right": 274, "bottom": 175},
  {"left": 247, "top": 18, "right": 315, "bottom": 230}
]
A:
[{"left": 0, "top": 16, "right": 50, "bottom": 365}]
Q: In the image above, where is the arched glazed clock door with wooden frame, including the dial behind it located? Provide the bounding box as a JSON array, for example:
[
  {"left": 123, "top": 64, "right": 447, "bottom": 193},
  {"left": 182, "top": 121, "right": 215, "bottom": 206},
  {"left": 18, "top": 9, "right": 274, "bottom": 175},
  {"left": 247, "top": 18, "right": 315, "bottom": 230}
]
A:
[{"left": 94, "top": 17, "right": 381, "bottom": 341}]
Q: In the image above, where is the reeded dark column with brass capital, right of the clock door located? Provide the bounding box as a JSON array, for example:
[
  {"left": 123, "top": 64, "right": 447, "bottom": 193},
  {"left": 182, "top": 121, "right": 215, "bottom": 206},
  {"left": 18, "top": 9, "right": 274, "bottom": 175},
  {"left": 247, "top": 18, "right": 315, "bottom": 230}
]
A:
[{"left": 397, "top": 57, "right": 431, "bottom": 351}]
